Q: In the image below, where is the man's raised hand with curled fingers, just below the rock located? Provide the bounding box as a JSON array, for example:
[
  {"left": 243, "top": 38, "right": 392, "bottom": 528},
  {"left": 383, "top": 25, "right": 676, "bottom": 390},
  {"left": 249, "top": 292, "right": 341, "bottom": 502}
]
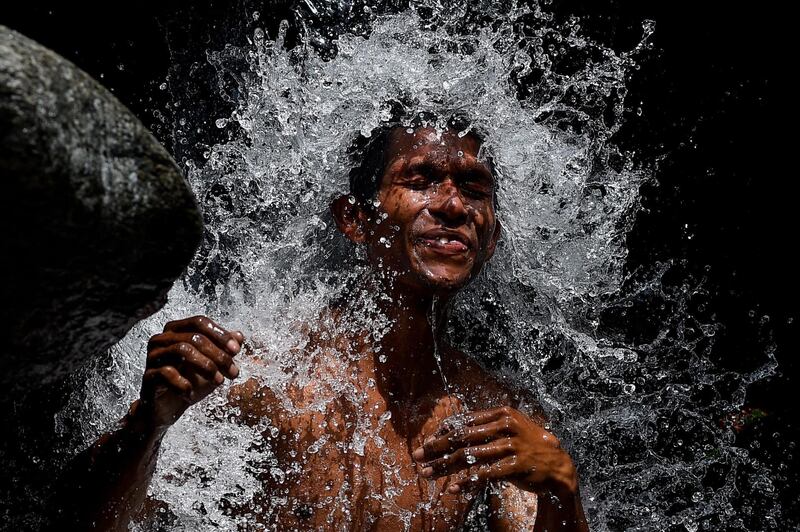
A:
[{"left": 136, "top": 316, "right": 244, "bottom": 429}]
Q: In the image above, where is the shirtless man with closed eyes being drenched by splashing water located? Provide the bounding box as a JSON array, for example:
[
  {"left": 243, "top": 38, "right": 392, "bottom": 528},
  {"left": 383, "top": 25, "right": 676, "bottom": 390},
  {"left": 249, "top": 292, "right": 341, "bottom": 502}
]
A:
[{"left": 61, "top": 118, "right": 588, "bottom": 531}]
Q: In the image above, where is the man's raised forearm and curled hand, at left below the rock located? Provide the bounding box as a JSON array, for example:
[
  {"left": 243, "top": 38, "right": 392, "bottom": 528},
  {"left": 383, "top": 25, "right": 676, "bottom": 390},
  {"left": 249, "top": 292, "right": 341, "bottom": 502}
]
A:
[{"left": 54, "top": 316, "right": 244, "bottom": 530}]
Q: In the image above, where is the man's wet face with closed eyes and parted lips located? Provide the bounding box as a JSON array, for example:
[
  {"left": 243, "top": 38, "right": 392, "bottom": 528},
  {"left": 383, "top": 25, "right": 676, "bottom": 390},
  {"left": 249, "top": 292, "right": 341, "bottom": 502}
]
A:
[{"left": 366, "top": 128, "right": 500, "bottom": 292}]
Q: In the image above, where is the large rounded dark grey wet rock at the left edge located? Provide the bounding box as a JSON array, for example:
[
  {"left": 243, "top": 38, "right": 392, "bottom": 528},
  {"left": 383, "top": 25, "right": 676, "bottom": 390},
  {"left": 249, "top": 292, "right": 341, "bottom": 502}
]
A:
[{"left": 0, "top": 26, "right": 202, "bottom": 393}]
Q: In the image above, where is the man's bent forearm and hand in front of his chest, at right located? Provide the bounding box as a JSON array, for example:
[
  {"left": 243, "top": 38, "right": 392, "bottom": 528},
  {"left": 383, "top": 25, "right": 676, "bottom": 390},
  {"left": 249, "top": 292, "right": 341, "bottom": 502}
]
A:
[{"left": 413, "top": 406, "right": 589, "bottom": 532}]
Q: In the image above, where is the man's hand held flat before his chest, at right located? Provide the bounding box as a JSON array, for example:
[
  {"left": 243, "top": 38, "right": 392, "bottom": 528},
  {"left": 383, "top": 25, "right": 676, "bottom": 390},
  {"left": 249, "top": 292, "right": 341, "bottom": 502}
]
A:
[{"left": 412, "top": 406, "right": 578, "bottom": 498}]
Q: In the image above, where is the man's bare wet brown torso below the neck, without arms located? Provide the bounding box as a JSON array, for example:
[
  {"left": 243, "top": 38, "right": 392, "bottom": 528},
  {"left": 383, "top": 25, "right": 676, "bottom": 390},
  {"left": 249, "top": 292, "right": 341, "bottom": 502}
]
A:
[{"left": 222, "top": 342, "right": 516, "bottom": 530}]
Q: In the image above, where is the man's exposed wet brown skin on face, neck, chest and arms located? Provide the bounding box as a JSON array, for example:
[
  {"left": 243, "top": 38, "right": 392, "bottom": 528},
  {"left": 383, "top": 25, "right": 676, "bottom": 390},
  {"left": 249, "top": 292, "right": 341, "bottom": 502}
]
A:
[{"left": 62, "top": 128, "right": 588, "bottom": 531}]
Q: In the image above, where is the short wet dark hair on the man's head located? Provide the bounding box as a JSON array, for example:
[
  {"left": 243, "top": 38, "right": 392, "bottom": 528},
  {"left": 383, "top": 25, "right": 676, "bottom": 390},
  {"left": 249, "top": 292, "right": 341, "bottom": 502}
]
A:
[{"left": 348, "top": 111, "right": 497, "bottom": 207}]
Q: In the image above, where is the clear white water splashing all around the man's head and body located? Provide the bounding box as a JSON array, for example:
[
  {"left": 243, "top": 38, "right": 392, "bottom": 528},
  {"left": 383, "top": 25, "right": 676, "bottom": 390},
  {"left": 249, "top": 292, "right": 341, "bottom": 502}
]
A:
[{"left": 57, "top": 0, "right": 780, "bottom": 530}]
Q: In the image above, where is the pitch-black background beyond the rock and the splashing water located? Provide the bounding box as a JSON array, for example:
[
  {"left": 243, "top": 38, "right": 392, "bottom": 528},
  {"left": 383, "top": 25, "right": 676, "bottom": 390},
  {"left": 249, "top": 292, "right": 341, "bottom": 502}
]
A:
[{"left": 0, "top": 0, "right": 800, "bottom": 518}]
